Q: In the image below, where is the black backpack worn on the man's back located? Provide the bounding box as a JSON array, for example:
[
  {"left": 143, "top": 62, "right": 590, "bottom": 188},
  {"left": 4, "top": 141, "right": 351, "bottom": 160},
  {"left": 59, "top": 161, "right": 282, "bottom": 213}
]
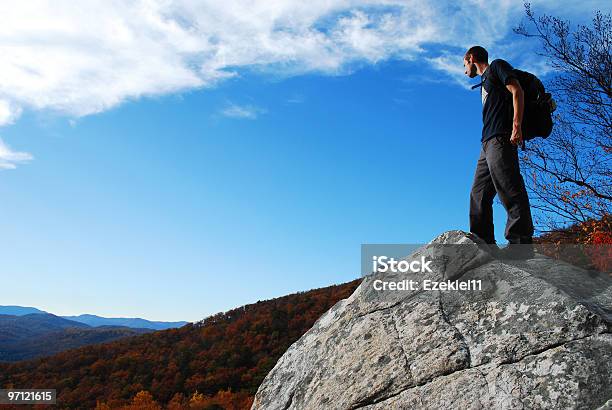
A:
[{"left": 472, "top": 68, "right": 557, "bottom": 141}]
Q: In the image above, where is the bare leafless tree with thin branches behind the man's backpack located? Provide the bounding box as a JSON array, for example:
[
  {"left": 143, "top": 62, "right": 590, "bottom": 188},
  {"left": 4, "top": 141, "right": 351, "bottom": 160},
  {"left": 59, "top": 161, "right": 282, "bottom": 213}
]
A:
[{"left": 514, "top": 3, "right": 612, "bottom": 230}]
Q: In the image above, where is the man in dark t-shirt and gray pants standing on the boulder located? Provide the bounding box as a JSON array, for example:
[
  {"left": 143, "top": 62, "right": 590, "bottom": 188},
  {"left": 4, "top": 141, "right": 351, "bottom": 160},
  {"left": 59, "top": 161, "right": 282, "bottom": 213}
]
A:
[{"left": 463, "top": 46, "right": 533, "bottom": 258}]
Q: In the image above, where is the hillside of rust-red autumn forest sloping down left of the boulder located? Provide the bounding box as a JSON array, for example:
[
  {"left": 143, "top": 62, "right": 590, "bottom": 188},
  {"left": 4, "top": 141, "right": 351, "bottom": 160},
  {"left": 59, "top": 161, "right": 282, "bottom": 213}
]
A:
[{"left": 0, "top": 279, "right": 360, "bottom": 410}]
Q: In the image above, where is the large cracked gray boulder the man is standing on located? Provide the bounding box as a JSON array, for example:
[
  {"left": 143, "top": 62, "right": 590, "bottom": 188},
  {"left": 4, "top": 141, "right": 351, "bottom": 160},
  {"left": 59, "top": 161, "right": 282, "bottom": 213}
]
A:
[{"left": 252, "top": 231, "right": 612, "bottom": 410}]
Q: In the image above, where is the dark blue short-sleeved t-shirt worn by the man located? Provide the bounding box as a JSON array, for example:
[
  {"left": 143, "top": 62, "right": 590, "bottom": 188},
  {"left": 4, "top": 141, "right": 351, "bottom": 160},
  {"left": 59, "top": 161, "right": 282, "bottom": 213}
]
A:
[{"left": 480, "top": 59, "right": 516, "bottom": 142}]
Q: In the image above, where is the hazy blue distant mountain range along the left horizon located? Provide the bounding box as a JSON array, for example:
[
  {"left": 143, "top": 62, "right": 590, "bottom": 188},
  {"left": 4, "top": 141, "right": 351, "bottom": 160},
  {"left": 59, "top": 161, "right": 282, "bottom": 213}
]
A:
[{"left": 0, "top": 306, "right": 189, "bottom": 330}]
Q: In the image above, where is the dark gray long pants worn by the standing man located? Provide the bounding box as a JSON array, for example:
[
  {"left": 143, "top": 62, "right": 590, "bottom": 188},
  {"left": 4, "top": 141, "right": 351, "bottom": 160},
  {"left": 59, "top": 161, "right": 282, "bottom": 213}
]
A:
[{"left": 470, "top": 135, "right": 533, "bottom": 243}]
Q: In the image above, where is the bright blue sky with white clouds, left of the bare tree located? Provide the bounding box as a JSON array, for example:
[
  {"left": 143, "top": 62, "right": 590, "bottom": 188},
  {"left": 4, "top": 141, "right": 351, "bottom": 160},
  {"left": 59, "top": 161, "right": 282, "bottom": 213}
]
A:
[{"left": 0, "top": 1, "right": 604, "bottom": 321}]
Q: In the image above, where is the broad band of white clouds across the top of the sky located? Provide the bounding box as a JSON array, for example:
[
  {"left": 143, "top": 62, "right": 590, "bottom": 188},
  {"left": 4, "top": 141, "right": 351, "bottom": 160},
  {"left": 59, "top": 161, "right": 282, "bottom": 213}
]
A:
[{"left": 0, "top": 0, "right": 588, "bottom": 125}]
